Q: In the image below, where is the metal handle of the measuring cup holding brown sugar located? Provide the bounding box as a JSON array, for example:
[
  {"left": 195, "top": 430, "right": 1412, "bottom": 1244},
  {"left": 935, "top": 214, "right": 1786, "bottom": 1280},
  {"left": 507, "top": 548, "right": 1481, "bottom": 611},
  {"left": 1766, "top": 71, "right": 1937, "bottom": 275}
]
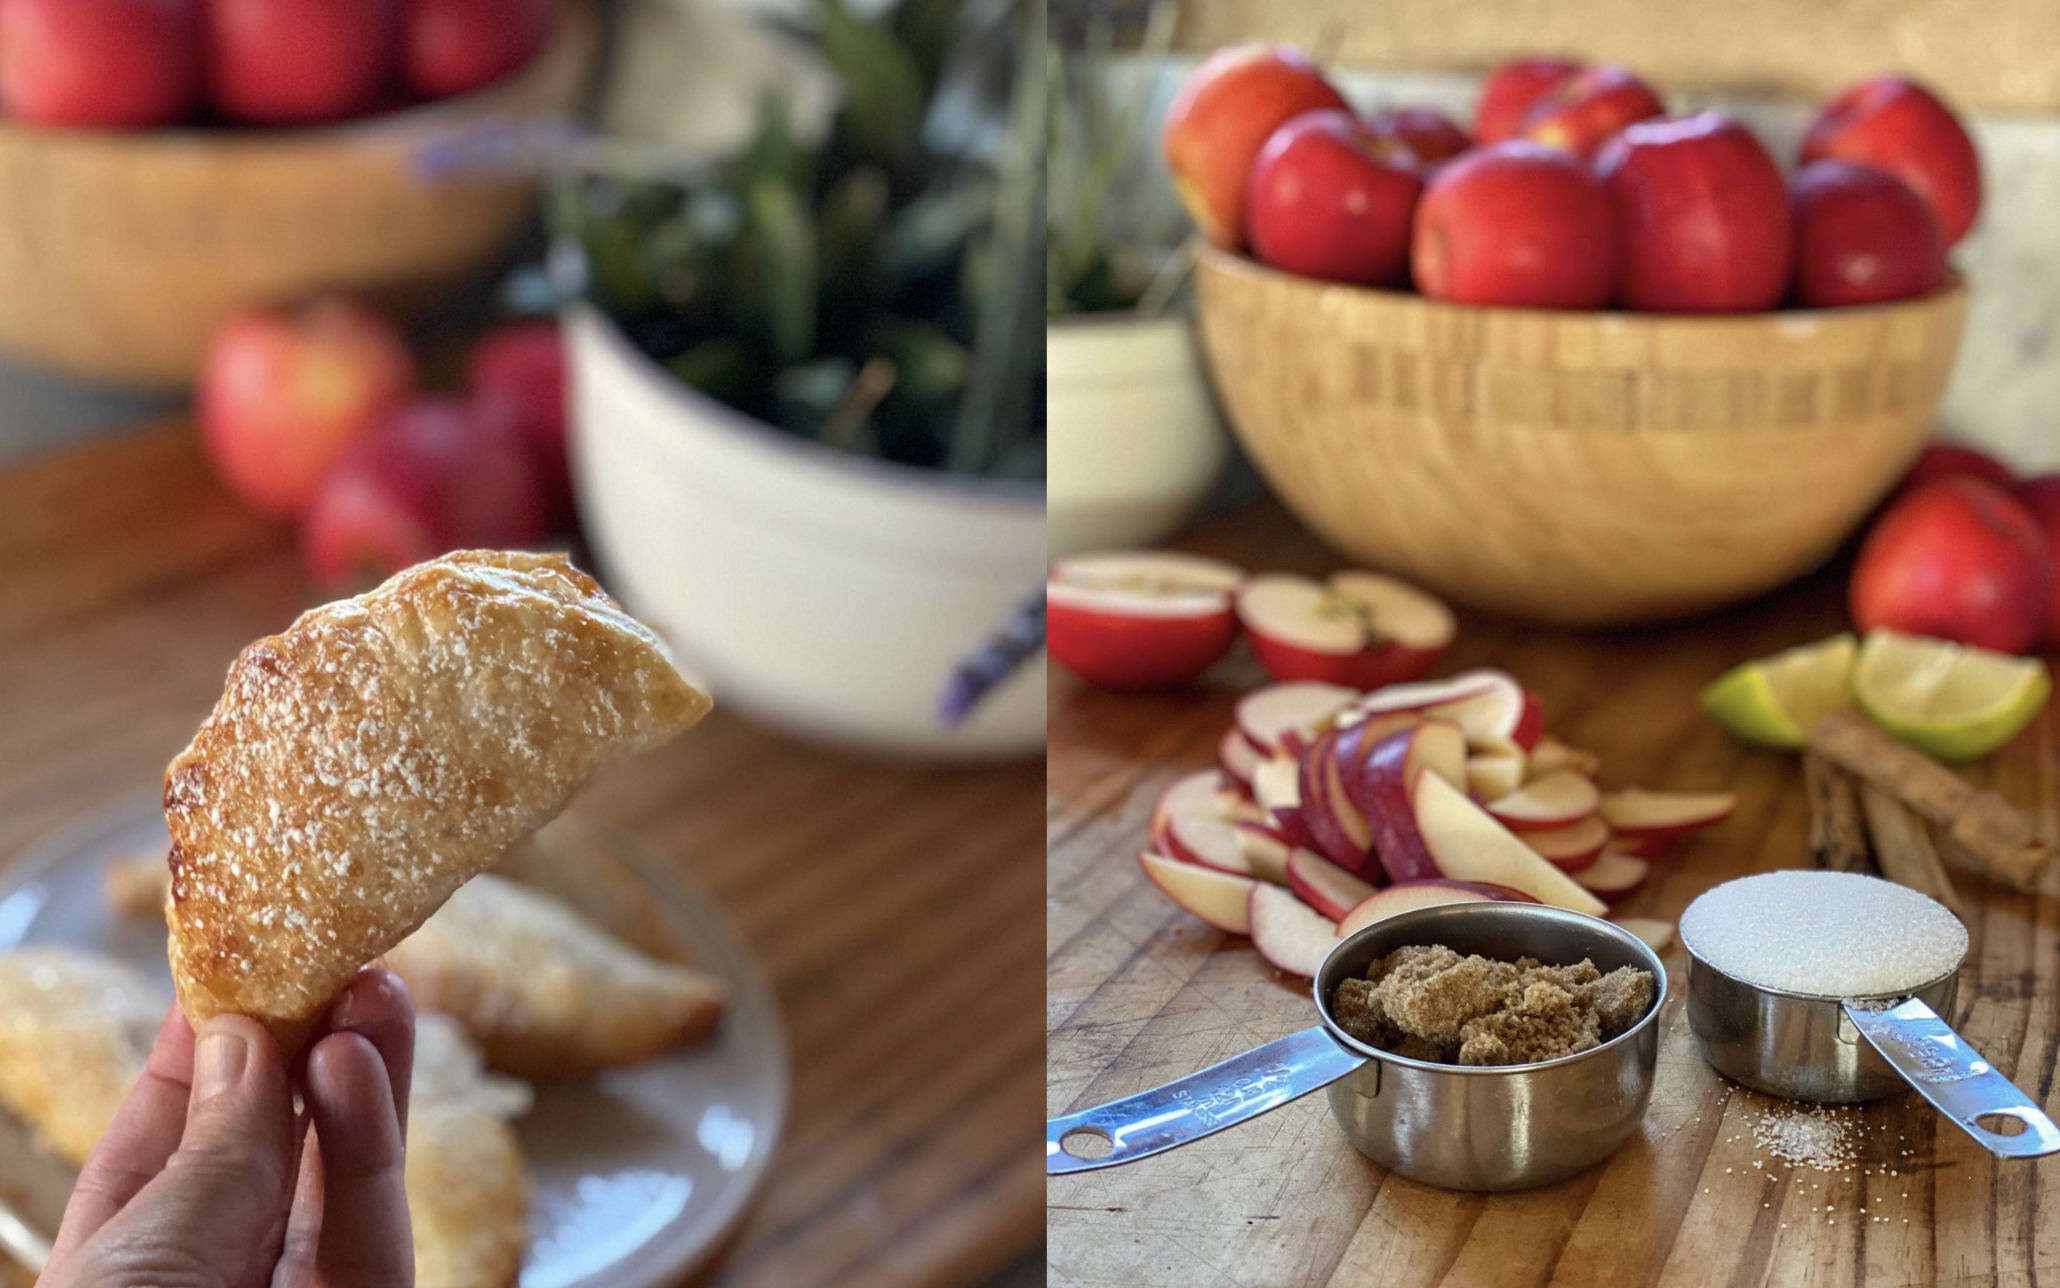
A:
[{"left": 1044, "top": 1024, "right": 1366, "bottom": 1177}]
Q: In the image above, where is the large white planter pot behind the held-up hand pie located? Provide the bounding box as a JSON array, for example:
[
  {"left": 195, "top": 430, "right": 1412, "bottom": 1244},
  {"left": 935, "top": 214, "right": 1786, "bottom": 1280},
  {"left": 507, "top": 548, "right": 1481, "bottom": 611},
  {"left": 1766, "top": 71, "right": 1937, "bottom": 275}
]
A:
[{"left": 567, "top": 305, "right": 1044, "bottom": 760}]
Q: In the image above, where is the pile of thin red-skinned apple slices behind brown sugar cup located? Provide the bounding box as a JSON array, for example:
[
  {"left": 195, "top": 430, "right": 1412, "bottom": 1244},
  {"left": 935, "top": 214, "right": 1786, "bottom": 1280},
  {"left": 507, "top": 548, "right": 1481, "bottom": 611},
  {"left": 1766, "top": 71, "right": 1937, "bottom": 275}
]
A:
[{"left": 1139, "top": 670, "right": 1732, "bottom": 977}]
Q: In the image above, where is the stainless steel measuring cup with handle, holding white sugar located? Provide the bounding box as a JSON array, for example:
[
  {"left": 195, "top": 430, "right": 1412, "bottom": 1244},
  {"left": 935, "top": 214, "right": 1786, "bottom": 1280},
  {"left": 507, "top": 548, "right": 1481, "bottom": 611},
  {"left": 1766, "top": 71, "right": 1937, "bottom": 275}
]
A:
[{"left": 1687, "top": 948, "right": 2060, "bottom": 1158}]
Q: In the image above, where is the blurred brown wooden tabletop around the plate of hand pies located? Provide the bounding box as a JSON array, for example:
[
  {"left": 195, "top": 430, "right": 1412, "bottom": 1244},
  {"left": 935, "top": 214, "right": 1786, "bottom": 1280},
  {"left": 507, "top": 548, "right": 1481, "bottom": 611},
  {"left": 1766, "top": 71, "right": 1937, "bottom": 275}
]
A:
[{"left": 0, "top": 422, "right": 1042, "bottom": 1288}]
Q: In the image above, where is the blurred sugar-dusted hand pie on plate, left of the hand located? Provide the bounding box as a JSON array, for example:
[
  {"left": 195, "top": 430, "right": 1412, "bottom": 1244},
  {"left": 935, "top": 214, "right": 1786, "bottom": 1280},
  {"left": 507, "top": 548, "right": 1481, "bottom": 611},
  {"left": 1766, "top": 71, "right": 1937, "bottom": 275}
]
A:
[{"left": 0, "top": 948, "right": 167, "bottom": 1166}]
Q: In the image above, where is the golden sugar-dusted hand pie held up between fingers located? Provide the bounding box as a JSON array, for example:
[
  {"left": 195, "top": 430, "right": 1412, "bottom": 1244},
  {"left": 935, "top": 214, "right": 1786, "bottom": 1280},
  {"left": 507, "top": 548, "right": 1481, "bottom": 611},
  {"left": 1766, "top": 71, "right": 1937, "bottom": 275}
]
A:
[{"left": 165, "top": 550, "right": 709, "bottom": 1057}]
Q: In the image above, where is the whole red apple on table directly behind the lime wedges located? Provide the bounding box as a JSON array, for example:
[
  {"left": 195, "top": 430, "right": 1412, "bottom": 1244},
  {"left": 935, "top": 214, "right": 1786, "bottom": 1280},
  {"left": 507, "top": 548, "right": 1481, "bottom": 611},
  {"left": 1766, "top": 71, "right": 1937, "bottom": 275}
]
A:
[{"left": 1850, "top": 476, "right": 2054, "bottom": 653}]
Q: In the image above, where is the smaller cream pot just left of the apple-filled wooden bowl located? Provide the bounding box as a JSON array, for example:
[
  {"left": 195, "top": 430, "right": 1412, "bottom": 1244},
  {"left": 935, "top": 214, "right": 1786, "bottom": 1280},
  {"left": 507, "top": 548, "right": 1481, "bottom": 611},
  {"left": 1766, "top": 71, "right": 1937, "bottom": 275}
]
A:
[{"left": 1044, "top": 313, "right": 1230, "bottom": 556}]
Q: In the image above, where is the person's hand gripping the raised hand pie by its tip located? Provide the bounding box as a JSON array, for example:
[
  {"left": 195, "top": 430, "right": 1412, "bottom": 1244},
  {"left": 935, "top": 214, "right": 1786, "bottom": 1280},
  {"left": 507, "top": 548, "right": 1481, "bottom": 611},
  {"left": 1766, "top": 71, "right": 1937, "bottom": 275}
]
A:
[{"left": 39, "top": 969, "right": 414, "bottom": 1288}]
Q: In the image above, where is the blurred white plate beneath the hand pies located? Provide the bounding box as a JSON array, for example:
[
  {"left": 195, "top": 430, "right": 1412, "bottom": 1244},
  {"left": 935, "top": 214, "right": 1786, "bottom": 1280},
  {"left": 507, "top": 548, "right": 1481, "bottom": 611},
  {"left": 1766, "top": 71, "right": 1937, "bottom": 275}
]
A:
[{"left": 0, "top": 793, "right": 787, "bottom": 1288}]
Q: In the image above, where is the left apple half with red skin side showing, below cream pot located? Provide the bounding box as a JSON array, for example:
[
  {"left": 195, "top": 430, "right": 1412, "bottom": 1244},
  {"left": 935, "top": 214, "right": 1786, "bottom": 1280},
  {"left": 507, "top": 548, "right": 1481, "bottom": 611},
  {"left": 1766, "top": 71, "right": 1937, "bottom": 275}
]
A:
[{"left": 1044, "top": 550, "right": 1244, "bottom": 688}]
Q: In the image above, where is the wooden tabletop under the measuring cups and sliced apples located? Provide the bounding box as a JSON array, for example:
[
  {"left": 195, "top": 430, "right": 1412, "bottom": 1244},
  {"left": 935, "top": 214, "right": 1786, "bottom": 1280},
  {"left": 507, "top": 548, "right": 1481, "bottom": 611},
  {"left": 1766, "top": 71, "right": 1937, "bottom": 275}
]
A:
[{"left": 1044, "top": 503, "right": 2060, "bottom": 1288}]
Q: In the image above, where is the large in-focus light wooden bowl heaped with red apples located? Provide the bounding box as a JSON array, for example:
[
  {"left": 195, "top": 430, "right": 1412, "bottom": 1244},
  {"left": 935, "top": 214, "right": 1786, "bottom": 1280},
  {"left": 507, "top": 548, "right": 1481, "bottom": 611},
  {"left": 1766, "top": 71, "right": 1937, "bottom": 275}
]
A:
[{"left": 1197, "top": 249, "right": 1967, "bottom": 626}]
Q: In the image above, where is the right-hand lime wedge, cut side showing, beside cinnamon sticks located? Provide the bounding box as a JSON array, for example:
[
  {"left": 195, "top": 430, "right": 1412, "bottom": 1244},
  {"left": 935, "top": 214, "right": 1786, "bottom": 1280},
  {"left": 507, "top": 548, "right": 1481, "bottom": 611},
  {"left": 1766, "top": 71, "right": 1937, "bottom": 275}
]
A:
[{"left": 1852, "top": 631, "right": 2052, "bottom": 760}]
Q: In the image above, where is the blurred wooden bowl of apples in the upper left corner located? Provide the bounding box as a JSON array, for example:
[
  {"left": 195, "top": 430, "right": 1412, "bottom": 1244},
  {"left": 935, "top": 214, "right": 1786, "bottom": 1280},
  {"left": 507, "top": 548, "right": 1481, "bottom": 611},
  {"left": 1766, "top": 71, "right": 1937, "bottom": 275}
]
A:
[{"left": 0, "top": 2, "right": 597, "bottom": 387}]
